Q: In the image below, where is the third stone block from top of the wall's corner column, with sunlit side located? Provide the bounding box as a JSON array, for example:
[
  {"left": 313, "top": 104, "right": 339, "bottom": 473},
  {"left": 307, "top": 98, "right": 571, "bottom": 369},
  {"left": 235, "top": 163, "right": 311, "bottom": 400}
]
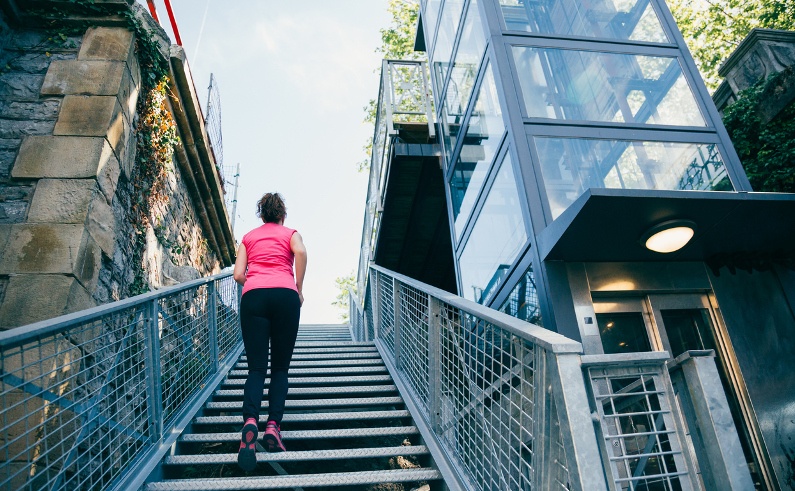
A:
[{"left": 53, "top": 95, "right": 130, "bottom": 158}]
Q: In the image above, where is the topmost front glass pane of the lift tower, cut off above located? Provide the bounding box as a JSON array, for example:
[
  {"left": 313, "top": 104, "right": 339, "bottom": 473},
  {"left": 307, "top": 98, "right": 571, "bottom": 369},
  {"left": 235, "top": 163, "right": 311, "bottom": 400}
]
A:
[{"left": 500, "top": 0, "right": 668, "bottom": 43}]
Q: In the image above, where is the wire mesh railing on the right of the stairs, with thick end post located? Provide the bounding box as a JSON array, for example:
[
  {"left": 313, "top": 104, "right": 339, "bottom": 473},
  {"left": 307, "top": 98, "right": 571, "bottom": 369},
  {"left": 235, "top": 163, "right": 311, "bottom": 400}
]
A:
[{"left": 351, "top": 265, "right": 607, "bottom": 490}]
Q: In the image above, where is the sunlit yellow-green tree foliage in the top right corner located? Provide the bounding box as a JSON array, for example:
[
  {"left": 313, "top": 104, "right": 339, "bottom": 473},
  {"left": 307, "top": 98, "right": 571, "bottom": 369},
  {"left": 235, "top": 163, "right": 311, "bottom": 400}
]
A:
[{"left": 668, "top": 0, "right": 795, "bottom": 91}]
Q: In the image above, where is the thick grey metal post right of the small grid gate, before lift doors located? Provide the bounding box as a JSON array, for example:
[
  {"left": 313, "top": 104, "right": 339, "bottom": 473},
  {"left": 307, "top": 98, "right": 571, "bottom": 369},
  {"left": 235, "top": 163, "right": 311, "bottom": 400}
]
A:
[{"left": 669, "top": 350, "right": 754, "bottom": 489}]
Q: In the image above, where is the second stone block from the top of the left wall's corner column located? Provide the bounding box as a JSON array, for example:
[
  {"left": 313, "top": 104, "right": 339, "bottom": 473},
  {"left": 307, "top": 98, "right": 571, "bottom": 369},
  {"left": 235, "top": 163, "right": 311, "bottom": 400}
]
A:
[{"left": 41, "top": 60, "right": 130, "bottom": 96}]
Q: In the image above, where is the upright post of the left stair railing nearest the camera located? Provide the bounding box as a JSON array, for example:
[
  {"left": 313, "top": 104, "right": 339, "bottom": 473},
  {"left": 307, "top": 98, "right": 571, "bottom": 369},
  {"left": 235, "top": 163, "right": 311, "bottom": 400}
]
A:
[{"left": 144, "top": 298, "right": 163, "bottom": 443}]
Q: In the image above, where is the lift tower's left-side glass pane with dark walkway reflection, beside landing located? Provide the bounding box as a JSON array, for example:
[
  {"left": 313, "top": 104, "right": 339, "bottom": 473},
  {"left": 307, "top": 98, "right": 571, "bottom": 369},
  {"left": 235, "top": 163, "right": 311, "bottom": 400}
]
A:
[{"left": 450, "top": 66, "right": 505, "bottom": 238}]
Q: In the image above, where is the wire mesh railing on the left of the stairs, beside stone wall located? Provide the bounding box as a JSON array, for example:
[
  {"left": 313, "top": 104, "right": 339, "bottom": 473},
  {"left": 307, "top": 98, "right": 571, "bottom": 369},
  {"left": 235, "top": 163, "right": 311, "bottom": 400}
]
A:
[{"left": 0, "top": 273, "right": 242, "bottom": 490}]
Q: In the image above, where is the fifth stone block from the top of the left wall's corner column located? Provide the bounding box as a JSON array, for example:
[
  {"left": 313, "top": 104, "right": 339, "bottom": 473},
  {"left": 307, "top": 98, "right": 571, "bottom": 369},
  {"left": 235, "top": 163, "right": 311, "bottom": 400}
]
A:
[{"left": 28, "top": 179, "right": 95, "bottom": 223}]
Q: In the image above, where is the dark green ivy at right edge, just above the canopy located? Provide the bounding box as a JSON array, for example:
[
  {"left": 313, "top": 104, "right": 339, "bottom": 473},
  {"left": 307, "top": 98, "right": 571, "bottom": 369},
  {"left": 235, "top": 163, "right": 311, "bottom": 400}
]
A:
[{"left": 723, "top": 67, "right": 795, "bottom": 193}]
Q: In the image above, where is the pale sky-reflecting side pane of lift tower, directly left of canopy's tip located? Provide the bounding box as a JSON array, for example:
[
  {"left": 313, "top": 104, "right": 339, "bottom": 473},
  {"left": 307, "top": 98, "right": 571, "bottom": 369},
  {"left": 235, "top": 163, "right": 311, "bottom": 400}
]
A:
[{"left": 460, "top": 154, "right": 527, "bottom": 304}]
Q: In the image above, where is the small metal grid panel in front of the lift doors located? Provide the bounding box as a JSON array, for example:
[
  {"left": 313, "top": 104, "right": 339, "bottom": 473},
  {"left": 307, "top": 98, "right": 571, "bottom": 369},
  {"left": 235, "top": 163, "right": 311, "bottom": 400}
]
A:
[{"left": 588, "top": 366, "right": 691, "bottom": 491}]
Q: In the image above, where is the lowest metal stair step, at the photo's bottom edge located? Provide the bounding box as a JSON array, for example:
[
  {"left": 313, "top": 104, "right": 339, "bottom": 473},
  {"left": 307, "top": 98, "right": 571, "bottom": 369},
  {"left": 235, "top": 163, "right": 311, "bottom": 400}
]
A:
[{"left": 146, "top": 468, "right": 442, "bottom": 491}]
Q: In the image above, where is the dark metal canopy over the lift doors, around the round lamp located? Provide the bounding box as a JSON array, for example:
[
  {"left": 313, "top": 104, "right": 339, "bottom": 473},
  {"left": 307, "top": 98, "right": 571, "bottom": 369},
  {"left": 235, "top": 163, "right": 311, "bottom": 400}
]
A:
[{"left": 538, "top": 188, "right": 795, "bottom": 269}]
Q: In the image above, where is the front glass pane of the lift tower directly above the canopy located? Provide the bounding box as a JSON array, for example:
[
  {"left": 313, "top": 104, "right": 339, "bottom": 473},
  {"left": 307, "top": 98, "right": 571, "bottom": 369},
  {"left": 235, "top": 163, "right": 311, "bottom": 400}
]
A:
[{"left": 535, "top": 138, "right": 733, "bottom": 218}]
